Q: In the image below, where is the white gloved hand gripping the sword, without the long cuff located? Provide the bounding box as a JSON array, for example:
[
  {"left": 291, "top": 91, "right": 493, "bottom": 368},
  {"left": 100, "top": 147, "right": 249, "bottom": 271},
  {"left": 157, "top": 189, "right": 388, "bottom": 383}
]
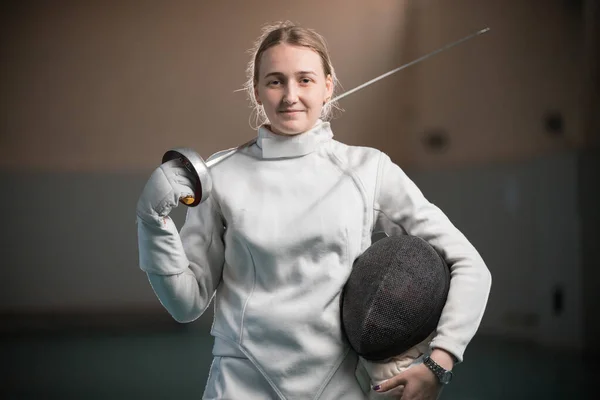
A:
[{"left": 137, "top": 159, "right": 195, "bottom": 224}]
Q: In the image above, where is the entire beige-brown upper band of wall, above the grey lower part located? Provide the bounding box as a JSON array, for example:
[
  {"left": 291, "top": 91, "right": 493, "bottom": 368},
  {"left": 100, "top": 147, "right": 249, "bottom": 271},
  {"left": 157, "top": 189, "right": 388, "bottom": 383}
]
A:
[{"left": 0, "top": 0, "right": 582, "bottom": 171}]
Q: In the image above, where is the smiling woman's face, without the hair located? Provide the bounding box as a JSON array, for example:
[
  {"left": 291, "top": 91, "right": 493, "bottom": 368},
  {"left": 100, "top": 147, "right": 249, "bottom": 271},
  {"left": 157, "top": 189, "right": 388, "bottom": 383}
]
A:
[{"left": 254, "top": 44, "right": 333, "bottom": 135}]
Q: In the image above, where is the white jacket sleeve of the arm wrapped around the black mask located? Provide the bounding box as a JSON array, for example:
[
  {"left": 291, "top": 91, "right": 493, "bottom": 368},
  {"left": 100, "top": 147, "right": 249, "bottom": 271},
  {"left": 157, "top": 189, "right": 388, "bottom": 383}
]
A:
[{"left": 374, "top": 153, "right": 491, "bottom": 362}]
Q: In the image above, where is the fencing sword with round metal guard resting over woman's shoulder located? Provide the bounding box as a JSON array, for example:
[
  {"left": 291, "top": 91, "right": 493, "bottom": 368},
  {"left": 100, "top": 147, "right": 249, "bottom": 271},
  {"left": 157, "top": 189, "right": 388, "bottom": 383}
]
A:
[{"left": 162, "top": 28, "right": 490, "bottom": 207}]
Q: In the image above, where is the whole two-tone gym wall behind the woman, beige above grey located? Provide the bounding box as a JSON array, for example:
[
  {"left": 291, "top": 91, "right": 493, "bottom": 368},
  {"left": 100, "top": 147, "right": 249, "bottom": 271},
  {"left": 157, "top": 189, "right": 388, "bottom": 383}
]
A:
[{"left": 0, "top": 0, "right": 597, "bottom": 348}]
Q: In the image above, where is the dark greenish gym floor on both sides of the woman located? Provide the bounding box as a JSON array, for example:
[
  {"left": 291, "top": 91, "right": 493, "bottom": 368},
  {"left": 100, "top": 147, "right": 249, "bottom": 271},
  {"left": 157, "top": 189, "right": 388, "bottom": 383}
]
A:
[{"left": 0, "top": 326, "right": 599, "bottom": 400}]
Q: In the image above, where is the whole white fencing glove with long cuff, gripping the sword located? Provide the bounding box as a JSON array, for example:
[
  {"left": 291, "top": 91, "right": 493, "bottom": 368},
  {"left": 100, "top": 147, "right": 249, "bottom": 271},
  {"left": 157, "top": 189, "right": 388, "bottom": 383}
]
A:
[{"left": 137, "top": 160, "right": 194, "bottom": 275}]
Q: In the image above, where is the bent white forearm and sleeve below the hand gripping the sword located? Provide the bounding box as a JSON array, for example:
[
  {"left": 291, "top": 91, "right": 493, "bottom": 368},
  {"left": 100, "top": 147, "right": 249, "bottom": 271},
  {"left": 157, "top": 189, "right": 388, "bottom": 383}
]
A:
[{"left": 137, "top": 197, "right": 224, "bottom": 322}]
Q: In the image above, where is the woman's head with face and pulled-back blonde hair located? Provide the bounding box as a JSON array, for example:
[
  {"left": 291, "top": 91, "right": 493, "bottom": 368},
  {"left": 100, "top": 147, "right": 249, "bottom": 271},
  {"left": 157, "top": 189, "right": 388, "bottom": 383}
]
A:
[{"left": 246, "top": 24, "right": 337, "bottom": 135}]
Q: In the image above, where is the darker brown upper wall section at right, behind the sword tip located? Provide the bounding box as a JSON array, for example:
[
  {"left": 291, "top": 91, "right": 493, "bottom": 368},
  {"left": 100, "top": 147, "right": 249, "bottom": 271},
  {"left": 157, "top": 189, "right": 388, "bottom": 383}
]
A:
[{"left": 407, "top": 0, "right": 582, "bottom": 167}]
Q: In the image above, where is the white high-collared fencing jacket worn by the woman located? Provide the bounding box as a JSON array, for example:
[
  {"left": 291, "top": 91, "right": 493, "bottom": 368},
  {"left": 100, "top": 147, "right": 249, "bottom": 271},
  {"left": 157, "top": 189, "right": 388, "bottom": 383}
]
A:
[{"left": 138, "top": 121, "right": 491, "bottom": 399}]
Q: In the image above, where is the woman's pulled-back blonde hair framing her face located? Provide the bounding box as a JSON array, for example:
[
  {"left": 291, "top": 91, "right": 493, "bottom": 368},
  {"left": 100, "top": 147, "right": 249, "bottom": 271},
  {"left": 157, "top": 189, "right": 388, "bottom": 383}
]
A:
[{"left": 244, "top": 21, "right": 341, "bottom": 127}]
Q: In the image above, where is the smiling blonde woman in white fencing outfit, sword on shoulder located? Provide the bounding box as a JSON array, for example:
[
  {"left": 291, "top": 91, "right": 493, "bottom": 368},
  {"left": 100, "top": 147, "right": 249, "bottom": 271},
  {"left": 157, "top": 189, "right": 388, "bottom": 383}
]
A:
[{"left": 137, "top": 23, "right": 491, "bottom": 400}]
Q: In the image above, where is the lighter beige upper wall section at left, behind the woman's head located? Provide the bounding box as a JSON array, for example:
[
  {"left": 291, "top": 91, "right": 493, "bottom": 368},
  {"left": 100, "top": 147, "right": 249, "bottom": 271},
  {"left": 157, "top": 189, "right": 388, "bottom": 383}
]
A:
[{"left": 0, "top": 0, "right": 412, "bottom": 170}]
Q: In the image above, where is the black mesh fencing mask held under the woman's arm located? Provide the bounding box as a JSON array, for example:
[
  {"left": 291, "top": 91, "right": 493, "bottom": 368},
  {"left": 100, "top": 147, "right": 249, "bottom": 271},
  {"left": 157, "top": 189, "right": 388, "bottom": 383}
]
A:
[{"left": 341, "top": 235, "right": 450, "bottom": 361}]
